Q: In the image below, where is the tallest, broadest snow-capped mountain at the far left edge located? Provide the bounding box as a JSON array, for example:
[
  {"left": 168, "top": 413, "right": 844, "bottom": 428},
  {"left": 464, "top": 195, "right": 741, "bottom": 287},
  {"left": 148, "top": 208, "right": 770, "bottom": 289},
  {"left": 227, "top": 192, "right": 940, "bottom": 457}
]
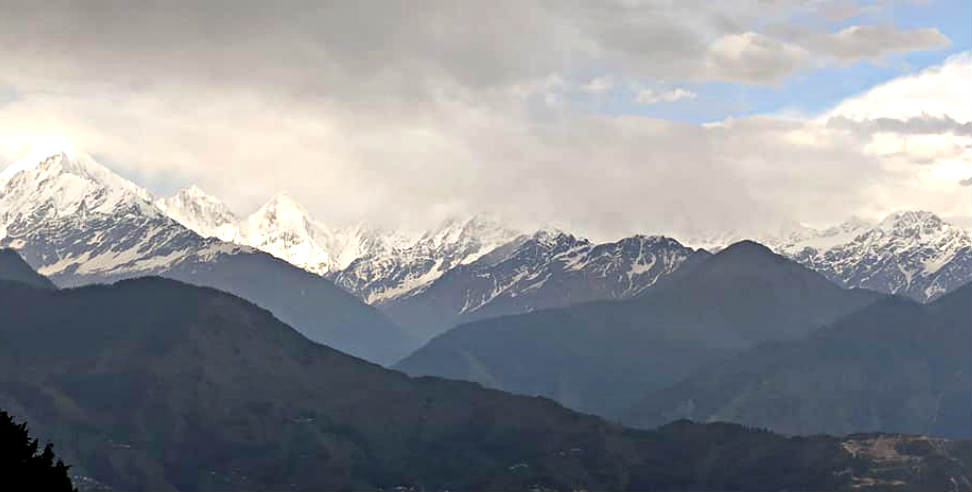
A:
[{"left": 0, "top": 152, "right": 239, "bottom": 285}]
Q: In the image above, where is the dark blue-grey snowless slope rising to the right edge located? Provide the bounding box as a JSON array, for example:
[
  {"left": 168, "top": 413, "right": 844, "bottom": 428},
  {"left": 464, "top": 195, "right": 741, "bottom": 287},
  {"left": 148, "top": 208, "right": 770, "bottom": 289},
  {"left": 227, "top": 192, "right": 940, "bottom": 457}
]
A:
[{"left": 626, "top": 284, "right": 972, "bottom": 437}]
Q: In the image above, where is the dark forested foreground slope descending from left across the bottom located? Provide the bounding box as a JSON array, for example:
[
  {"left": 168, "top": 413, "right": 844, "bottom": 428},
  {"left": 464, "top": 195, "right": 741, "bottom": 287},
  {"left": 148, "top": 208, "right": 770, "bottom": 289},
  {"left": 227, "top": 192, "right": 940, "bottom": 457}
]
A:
[{"left": 0, "top": 278, "right": 970, "bottom": 490}]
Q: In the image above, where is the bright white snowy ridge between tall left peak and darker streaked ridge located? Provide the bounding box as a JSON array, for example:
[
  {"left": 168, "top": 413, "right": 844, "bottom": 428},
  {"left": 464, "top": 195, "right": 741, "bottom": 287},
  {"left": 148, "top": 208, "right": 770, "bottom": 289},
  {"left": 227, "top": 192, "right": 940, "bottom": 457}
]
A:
[{"left": 156, "top": 187, "right": 518, "bottom": 304}]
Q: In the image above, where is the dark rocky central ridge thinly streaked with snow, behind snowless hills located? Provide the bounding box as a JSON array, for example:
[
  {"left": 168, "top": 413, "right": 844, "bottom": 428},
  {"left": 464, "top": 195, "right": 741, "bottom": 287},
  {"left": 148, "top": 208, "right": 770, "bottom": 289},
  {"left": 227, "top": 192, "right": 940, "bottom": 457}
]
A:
[{"left": 381, "top": 231, "right": 708, "bottom": 339}]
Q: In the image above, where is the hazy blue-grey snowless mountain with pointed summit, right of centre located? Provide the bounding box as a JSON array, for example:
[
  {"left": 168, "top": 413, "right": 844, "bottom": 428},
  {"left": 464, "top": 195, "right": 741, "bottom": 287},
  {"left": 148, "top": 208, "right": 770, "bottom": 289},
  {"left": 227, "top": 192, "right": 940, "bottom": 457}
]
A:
[{"left": 396, "top": 242, "right": 878, "bottom": 417}]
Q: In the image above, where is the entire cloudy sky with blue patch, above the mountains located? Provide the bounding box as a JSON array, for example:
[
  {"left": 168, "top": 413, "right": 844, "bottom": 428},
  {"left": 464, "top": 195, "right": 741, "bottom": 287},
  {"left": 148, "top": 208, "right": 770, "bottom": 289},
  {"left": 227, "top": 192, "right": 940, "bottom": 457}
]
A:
[{"left": 0, "top": 0, "right": 972, "bottom": 238}]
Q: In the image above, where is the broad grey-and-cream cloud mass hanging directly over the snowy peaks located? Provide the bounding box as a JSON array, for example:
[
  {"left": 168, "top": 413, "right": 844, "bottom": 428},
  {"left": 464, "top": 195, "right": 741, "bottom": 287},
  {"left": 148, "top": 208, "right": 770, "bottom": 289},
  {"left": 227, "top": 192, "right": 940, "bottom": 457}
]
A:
[{"left": 0, "top": 0, "right": 964, "bottom": 236}]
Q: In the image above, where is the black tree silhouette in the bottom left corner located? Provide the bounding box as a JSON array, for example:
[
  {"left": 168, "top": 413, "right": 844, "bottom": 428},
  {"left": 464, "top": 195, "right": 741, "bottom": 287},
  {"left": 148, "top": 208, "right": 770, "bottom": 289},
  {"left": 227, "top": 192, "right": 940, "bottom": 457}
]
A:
[{"left": 0, "top": 410, "right": 76, "bottom": 491}]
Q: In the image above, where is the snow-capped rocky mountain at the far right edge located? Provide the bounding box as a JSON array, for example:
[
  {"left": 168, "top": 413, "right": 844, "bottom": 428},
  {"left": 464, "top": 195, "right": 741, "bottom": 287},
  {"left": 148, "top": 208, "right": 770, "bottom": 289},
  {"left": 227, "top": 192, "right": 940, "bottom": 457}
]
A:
[{"left": 776, "top": 211, "right": 972, "bottom": 301}]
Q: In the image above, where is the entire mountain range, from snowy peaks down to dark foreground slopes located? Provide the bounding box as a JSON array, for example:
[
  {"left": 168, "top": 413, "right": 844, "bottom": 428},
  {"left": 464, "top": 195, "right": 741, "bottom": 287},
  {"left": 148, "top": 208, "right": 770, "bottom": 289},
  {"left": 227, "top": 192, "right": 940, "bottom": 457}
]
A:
[{"left": 0, "top": 146, "right": 972, "bottom": 489}]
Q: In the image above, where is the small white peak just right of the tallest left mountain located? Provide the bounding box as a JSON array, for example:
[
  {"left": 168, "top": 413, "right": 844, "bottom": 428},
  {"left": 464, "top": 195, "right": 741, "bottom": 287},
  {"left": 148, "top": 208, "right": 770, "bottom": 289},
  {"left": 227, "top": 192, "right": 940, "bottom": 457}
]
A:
[{"left": 155, "top": 185, "right": 238, "bottom": 241}]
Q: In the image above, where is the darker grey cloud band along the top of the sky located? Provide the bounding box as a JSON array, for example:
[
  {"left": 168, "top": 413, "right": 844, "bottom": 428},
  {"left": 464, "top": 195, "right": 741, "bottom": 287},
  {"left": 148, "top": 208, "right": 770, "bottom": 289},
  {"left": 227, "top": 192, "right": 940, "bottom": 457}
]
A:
[{"left": 0, "top": 0, "right": 944, "bottom": 93}]
